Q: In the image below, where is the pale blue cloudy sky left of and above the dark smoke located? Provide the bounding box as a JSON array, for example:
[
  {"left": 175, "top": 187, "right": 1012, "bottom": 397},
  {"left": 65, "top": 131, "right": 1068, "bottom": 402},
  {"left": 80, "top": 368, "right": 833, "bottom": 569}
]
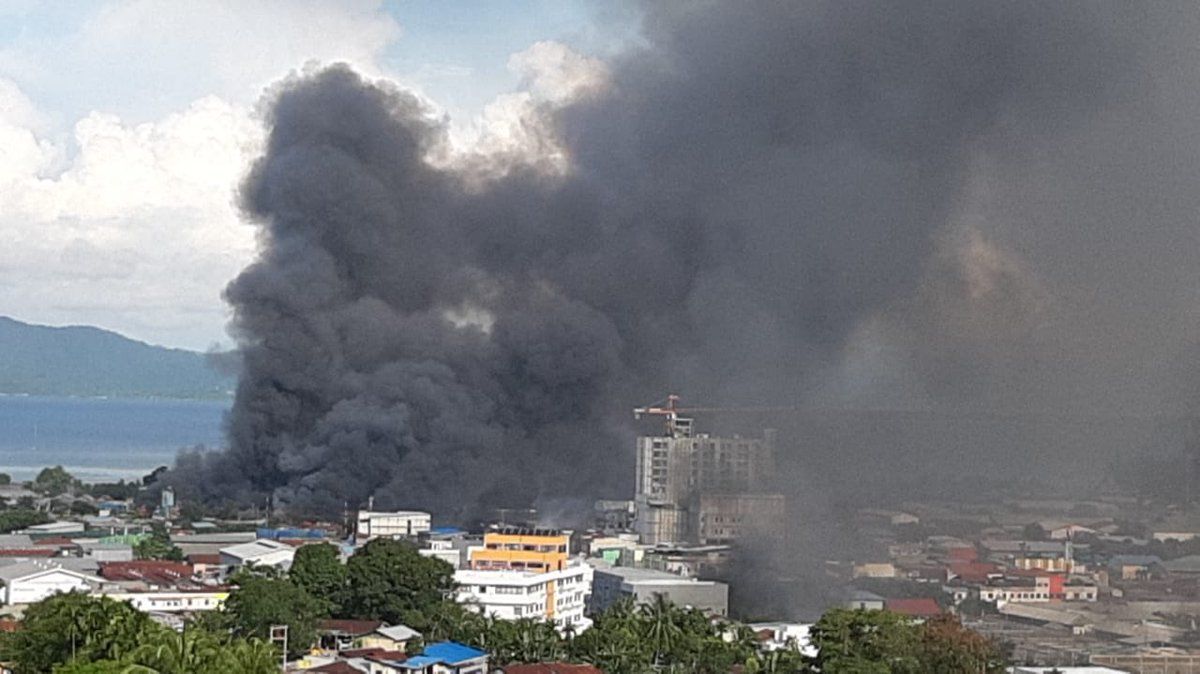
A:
[{"left": 0, "top": 0, "right": 636, "bottom": 350}]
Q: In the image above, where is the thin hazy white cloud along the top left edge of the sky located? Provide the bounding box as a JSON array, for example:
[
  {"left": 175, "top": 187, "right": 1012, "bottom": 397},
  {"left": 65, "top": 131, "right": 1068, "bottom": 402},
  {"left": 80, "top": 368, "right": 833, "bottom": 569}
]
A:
[{"left": 0, "top": 0, "right": 401, "bottom": 118}]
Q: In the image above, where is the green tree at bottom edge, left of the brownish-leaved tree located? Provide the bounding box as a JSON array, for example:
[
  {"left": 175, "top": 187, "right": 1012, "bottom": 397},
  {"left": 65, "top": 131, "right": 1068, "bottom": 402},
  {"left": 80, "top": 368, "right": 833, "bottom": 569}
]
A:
[{"left": 810, "top": 608, "right": 922, "bottom": 674}]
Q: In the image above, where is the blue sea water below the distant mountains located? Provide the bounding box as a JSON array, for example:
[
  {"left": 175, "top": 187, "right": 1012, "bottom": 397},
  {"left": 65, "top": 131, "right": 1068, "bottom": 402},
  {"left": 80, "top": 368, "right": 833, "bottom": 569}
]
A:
[{"left": 0, "top": 395, "right": 229, "bottom": 482}]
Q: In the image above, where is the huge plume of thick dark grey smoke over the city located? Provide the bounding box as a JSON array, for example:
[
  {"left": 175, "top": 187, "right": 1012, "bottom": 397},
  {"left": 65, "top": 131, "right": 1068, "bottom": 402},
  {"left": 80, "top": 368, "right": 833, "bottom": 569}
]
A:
[{"left": 174, "top": 0, "right": 1200, "bottom": 566}]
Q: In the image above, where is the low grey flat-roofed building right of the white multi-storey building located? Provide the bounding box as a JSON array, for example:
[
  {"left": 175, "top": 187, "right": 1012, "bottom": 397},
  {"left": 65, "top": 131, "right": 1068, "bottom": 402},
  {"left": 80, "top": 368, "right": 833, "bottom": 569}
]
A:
[{"left": 589, "top": 566, "right": 730, "bottom": 615}]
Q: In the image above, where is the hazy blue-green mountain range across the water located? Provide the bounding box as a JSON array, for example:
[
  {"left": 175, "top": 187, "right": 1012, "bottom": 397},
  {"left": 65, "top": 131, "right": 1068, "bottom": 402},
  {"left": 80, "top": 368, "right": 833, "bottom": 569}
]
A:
[{"left": 0, "top": 317, "right": 235, "bottom": 398}]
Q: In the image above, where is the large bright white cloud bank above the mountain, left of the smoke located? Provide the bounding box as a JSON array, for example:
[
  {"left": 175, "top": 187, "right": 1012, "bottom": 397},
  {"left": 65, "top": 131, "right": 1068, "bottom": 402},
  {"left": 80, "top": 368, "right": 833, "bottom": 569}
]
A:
[{"left": 0, "top": 85, "right": 262, "bottom": 348}]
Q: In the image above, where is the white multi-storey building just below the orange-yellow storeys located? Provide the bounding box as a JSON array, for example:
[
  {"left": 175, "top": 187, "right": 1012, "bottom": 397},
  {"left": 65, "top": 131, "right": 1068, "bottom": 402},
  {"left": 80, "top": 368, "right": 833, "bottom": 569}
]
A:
[{"left": 454, "top": 561, "right": 592, "bottom": 632}]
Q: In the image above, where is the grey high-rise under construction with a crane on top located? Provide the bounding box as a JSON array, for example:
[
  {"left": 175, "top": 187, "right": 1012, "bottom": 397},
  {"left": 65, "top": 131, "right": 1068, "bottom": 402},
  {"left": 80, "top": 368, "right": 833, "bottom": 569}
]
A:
[{"left": 635, "top": 396, "right": 785, "bottom": 544}]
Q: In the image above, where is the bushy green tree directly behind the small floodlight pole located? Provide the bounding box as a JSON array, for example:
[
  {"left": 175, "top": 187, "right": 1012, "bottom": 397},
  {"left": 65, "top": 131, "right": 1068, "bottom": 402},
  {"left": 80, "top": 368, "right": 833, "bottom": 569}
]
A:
[{"left": 224, "top": 573, "right": 329, "bottom": 656}]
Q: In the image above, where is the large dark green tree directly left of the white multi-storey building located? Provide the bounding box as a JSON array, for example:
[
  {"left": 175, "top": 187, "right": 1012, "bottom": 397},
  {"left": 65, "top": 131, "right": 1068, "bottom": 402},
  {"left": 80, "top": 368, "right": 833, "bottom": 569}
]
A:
[{"left": 342, "top": 538, "right": 454, "bottom": 624}]
